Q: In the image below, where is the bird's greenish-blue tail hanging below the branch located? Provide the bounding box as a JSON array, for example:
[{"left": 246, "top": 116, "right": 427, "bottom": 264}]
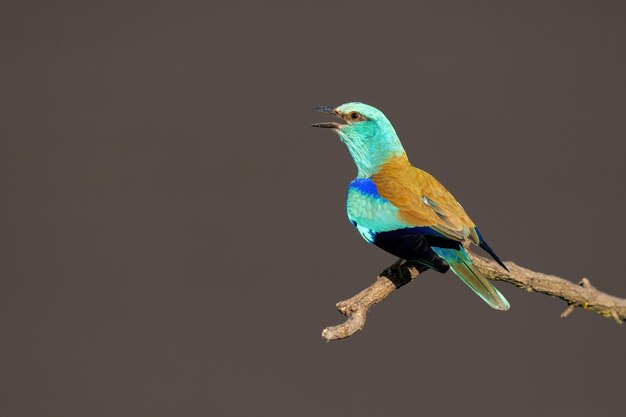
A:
[{"left": 433, "top": 247, "right": 511, "bottom": 310}]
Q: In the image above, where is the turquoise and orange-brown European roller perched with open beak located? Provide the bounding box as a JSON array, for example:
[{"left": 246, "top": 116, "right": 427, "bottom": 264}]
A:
[{"left": 312, "top": 103, "right": 509, "bottom": 310}]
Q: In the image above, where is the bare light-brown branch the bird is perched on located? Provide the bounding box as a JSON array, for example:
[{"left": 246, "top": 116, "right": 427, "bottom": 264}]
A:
[{"left": 322, "top": 252, "right": 626, "bottom": 341}]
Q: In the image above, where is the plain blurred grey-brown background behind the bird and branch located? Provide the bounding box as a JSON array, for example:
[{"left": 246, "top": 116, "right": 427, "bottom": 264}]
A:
[{"left": 0, "top": 1, "right": 626, "bottom": 417}]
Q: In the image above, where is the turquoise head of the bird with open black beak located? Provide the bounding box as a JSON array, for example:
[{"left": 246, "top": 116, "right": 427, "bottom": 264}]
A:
[{"left": 311, "top": 102, "right": 404, "bottom": 178}]
